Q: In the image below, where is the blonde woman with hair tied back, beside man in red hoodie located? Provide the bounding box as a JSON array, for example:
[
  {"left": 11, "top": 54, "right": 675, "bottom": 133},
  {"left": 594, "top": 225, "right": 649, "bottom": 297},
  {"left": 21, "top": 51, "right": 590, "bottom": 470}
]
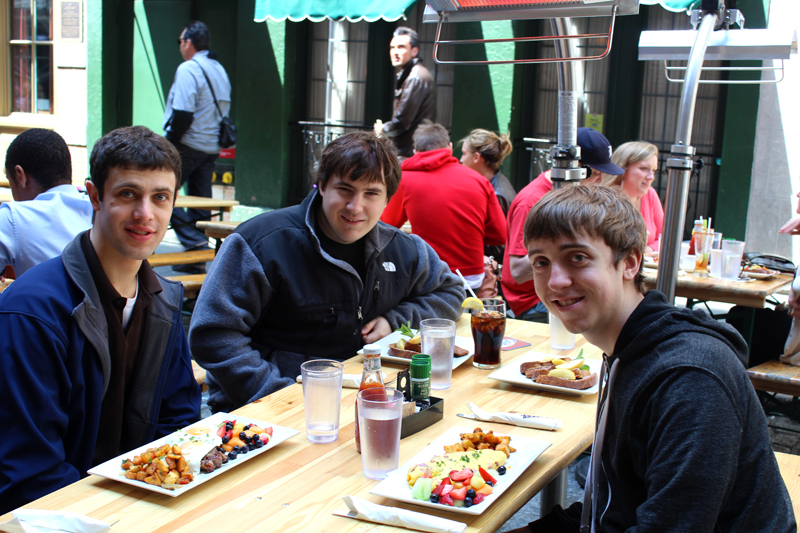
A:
[{"left": 461, "top": 129, "right": 517, "bottom": 216}]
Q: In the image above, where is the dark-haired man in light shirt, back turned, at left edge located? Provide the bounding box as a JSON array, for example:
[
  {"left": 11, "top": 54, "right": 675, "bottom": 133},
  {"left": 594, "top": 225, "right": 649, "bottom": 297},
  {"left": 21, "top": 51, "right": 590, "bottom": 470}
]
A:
[{"left": 0, "top": 128, "right": 92, "bottom": 277}]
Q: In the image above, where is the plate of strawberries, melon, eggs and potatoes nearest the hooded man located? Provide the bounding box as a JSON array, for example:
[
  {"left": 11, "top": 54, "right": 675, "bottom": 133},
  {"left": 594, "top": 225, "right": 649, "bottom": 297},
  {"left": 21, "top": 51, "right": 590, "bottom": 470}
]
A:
[{"left": 370, "top": 424, "right": 552, "bottom": 515}]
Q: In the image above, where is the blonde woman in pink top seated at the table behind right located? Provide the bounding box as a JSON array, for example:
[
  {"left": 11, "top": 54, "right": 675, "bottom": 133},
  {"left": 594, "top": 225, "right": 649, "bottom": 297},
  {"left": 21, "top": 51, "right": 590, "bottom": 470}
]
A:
[{"left": 603, "top": 141, "right": 664, "bottom": 252}]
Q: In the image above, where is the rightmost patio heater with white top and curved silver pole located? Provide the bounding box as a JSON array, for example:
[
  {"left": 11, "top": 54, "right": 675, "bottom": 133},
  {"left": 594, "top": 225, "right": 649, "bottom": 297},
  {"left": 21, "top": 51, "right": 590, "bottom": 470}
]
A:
[{"left": 639, "top": 0, "right": 797, "bottom": 302}]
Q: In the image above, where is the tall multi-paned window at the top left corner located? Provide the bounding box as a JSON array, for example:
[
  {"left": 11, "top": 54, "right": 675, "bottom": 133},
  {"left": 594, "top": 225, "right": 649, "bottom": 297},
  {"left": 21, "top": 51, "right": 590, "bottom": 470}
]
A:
[{"left": 9, "top": 0, "right": 53, "bottom": 114}]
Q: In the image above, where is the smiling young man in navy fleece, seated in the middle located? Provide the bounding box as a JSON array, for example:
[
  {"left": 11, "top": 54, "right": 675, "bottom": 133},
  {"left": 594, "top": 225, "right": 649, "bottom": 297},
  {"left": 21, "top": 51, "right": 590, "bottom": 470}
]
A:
[{"left": 189, "top": 132, "right": 465, "bottom": 411}]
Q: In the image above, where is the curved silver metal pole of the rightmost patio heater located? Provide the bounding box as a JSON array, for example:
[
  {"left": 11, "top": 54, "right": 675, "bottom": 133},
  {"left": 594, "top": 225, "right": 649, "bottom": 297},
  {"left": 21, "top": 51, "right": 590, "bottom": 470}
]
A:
[{"left": 656, "top": 13, "right": 718, "bottom": 302}]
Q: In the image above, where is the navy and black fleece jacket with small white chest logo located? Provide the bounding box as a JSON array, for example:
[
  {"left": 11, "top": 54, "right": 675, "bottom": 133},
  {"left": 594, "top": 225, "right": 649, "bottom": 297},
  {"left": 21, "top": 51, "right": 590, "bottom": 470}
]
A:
[{"left": 189, "top": 190, "right": 464, "bottom": 411}]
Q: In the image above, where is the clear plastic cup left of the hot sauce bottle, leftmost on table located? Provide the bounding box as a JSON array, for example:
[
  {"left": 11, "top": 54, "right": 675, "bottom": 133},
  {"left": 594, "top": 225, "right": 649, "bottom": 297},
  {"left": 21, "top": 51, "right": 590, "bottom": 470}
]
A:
[{"left": 300, "top": 359, "right": 344, "bottom": 443}]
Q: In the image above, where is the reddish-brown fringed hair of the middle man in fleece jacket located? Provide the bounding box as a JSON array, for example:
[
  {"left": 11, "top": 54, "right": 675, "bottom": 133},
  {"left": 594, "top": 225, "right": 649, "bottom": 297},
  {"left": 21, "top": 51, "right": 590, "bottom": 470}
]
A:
[{"left": 317, "top": 131, "right": 400, "bottom": 200}]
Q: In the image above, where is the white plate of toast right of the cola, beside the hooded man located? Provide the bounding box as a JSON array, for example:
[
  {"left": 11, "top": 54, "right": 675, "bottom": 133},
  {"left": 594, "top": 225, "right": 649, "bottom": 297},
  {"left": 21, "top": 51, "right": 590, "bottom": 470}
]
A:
[{"left": 489, "top": 350, "right": 603, "bottom": 396}]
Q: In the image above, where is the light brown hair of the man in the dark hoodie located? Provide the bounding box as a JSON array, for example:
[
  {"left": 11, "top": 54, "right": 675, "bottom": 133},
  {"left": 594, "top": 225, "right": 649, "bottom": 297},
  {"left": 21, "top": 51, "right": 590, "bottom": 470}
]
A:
[{"left": 524, "top": 185, "right": 647, "bottom": 294}]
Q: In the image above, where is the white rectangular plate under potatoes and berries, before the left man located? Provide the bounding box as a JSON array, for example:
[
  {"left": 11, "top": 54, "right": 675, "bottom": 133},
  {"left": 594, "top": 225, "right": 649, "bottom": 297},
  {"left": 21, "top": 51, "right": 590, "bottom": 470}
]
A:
[{"left": 89, "top": 413, "right": 300, "bottom": 498}]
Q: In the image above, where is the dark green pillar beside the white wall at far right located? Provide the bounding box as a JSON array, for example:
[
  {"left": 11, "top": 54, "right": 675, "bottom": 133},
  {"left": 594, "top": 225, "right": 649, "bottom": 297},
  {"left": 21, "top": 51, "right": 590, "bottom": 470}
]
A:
[{"left": 714, "top": 0, "right": 768, "bottom": 239}]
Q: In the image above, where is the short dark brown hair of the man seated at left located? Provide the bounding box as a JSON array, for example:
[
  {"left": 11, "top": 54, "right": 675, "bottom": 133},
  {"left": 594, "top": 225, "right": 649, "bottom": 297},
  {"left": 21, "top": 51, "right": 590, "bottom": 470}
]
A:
[{"left": 89, "top": 126, "right": 181, "bottom": 200}]
